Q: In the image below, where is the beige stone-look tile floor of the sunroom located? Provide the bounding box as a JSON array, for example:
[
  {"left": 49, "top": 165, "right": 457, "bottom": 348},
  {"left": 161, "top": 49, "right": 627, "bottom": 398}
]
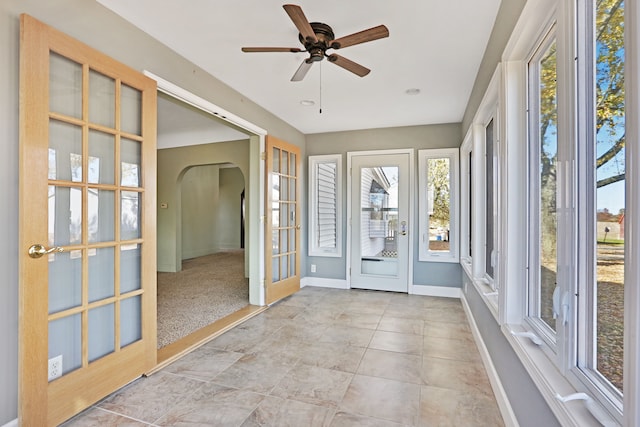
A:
[{"left": 65, "top": 286, "right": 504, "bottom": 427}]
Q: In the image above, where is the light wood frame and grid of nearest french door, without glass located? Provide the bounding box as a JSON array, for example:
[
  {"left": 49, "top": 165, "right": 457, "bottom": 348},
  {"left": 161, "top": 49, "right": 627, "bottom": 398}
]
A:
[{"left": 18, "top": 15, "right": 157, "bottom": 426}]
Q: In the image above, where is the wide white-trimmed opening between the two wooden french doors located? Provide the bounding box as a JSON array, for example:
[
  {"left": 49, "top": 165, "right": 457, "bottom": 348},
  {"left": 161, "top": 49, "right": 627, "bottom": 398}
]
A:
[{"left": 148, "top": 73, "right": 266, "bottom": 366}]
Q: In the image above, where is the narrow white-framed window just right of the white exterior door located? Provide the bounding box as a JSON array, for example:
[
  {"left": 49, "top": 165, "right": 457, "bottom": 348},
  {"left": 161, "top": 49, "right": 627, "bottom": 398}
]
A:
[{"left": 418, "top": 148, "right": 459, "bottom": 262}]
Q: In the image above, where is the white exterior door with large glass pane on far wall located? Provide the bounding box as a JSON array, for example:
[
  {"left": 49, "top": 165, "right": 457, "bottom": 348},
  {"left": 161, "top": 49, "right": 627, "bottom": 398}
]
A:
[{"left": 349, "top": 152, "right": 412, "bottom": 292}]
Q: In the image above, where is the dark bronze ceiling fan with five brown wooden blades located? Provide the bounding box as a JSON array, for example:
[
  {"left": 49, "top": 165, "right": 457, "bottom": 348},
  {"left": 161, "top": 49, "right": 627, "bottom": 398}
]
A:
[{"left": 242, "top": 4, "right": 389, "bottom": 82}]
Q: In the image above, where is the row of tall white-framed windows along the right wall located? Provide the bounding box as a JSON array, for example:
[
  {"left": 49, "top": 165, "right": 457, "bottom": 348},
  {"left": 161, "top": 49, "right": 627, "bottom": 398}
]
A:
[{"left": 472, "top": 0, "right": 640, "bottom": 425}]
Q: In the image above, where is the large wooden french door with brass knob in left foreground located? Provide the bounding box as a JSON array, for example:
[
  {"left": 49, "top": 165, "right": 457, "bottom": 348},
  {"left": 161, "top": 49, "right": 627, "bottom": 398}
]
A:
[{"left": 19, "top": 15, "right": 157, "bottom": 426}]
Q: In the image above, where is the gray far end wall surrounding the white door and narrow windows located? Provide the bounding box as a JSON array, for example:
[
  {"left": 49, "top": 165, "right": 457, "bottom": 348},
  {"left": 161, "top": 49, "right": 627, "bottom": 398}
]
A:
[{"left": 304, "top": 123, "right": 462, "bottom": 287}]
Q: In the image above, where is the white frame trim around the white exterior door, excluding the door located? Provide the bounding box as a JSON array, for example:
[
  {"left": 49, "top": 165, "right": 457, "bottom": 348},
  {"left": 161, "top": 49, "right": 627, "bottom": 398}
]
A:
[{"left": 345, "top": 148, "right": 418, "bottom": 294}]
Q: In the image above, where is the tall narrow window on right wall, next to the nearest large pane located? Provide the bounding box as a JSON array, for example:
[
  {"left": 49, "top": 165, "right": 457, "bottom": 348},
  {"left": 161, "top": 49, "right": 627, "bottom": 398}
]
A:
[{"left": 527, "top": 30, "right": 566, "bottom": 344}]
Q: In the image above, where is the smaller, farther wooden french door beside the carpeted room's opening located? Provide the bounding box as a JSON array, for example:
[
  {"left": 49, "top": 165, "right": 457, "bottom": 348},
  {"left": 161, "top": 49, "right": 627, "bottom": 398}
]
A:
[{"left": 265, "top": 136, "right": 300, "bottom": 304}]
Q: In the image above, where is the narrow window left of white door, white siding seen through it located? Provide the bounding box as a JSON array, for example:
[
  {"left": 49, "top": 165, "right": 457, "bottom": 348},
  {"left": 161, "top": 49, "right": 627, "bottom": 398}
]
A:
[{"left": 309, "top": 154, "right": 342, "bottom": 257}]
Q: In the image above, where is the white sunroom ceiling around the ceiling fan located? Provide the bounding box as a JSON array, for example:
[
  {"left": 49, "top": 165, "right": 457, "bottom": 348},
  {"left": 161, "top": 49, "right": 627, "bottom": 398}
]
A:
[{"left": 97, "top": 0, "right": 500, "bottom": 134}]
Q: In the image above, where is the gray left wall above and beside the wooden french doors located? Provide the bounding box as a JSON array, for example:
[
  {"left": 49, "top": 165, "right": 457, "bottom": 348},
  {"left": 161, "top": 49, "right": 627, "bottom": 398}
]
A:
[{"left": 0, "top": 0, "right": 306, "bottom": 425}]
